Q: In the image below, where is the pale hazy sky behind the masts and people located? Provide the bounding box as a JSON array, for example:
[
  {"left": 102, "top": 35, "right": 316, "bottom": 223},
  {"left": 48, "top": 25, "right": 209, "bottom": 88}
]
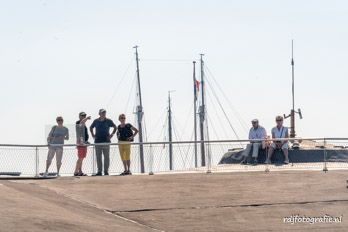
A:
[{"left": 0, "top": 0, "right": 348, "bottom": 144}]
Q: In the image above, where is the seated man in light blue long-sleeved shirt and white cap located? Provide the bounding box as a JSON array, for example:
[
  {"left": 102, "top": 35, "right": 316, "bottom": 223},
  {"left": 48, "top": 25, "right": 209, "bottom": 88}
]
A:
[{"left": 241, "top": 119, "right": 267, "bottom": 165}]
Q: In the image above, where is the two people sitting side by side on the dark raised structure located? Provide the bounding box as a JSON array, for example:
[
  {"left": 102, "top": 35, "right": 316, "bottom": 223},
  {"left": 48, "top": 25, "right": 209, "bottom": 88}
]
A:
[{"left": 241, "top": 116, "right": 289, "bottom": 165}]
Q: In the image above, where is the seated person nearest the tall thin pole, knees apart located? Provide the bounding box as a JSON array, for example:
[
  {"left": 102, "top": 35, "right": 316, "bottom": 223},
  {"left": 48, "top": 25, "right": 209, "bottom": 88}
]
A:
[{"left": 265, "top": 116, "right": 289, "bottom": 164}]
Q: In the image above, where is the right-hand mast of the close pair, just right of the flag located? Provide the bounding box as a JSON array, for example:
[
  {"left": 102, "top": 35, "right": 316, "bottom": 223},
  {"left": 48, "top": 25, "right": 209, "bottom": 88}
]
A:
[{"left": 199, "top": 54, "right": 205, "bottom": 167}]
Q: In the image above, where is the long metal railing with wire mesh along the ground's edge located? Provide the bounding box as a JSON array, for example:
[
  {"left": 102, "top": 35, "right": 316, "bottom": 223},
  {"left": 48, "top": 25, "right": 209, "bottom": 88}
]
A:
[{"left": 0, "top": 138, "right": 348, "bottom": 177}]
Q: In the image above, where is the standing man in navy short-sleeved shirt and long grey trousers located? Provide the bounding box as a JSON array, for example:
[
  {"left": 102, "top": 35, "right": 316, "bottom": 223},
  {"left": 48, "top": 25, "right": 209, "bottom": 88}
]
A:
[{"left": 90, "top": 109, "right": 117, "bottom": 176}]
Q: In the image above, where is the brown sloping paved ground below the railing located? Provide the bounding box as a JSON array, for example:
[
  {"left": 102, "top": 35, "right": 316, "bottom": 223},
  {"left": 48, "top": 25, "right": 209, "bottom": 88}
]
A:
[{"left": 0, "top": 171, "right": 348, "bottom": 232}]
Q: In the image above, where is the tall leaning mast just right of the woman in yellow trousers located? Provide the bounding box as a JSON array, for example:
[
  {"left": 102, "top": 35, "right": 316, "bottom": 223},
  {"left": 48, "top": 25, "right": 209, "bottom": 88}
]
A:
[{"left": 134, "top": 46, "right": 145, "bottom": 173}]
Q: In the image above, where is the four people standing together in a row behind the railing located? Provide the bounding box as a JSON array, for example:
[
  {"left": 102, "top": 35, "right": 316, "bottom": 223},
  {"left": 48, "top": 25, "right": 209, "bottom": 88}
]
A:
[{"left": 43, "top": 109, "right": 138, "bottom": 177}]
